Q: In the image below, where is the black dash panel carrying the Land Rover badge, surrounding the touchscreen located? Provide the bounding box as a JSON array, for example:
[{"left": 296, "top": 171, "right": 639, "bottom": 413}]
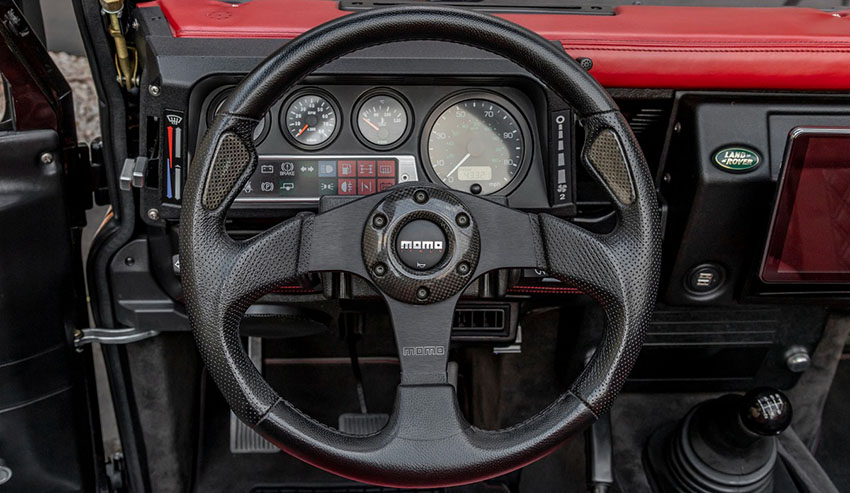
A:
[{"left": 659, "top": 91, "right": 850, "bottom": 306}]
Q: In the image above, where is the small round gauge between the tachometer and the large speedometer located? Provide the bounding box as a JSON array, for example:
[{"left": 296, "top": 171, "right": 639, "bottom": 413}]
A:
[{"left": 354, "top": 90, "right": 410, "bottom": 149}]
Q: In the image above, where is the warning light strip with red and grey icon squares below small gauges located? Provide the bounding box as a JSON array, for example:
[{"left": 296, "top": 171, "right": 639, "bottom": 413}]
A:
[{"left": 236, "top": 156, "right": 416, "bottom": 202}]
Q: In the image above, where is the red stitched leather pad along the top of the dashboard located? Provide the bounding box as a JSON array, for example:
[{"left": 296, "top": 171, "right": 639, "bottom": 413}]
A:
[{"left": 140, "top": 0, "right": 850, "bottom": 90}]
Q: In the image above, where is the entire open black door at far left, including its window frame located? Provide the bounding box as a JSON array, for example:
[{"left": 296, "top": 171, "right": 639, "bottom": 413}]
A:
[{"left": 0, "top": 0, "right": 104, "bottom": 493}]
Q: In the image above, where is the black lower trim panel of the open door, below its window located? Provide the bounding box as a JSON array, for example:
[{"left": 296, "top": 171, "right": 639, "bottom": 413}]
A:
[{"left": 0, "top": 130, "right": 92, "bottom": 491}]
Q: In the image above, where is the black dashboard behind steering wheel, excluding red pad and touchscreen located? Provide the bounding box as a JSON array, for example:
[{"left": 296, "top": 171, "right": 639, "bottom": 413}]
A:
[{"left": 122, "top": 7, "right": 847, "bottom": 305}]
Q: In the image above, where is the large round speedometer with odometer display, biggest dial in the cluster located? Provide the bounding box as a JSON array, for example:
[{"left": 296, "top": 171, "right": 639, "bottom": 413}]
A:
[{"left": 422, "top": 93, "right": 527, "bottom": 195}]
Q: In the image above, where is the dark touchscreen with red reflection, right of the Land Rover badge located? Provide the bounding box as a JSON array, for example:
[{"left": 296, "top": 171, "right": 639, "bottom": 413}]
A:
[{"left": 761, "top": 128, "right": 850, "bottom": 283}]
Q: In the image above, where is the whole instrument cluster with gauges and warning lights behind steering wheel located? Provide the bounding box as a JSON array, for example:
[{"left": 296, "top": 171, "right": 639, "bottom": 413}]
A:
[{"left": 198, "top": 84, "right": 551, "bottom": 208}]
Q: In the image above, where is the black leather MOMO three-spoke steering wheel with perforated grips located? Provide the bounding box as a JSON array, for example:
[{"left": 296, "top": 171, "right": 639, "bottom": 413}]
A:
[{"left": 180, "top": 7, "right": 661, "bottom": 487}]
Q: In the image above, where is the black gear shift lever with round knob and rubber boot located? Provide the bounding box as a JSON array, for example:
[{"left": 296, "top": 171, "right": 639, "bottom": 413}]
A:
[{"left": 646, "top": 387, "right": 792, "bottom": 493}]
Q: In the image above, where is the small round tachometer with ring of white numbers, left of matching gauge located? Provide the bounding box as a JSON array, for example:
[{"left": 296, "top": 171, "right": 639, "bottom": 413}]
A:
[{"left": 280, "top": 90, "right": 339, "bottom": 149}]
